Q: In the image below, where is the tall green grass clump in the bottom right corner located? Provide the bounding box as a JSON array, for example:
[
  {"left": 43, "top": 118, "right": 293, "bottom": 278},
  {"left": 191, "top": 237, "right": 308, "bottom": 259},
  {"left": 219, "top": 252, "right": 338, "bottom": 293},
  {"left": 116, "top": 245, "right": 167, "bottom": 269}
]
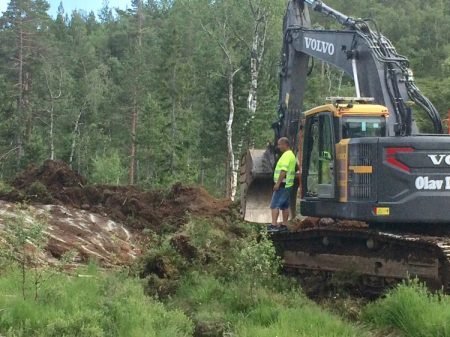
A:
[{"left": 361, "top": 280, "right": 450, "bottom": 337}]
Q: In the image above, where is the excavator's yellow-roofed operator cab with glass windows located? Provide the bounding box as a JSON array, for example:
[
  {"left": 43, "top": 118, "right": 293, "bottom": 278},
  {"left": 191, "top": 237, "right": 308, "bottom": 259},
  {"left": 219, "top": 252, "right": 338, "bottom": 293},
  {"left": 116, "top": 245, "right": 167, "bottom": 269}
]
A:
[{"left": 299, "top": 98, "right": 388, "bottom": 199}]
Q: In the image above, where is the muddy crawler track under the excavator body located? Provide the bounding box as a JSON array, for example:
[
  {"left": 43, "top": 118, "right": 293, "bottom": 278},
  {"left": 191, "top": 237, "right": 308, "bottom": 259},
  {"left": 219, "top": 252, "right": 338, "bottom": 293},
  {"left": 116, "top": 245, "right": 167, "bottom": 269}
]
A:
[{"left": 271, "top": 226, "right": 450, "bottom": 293}]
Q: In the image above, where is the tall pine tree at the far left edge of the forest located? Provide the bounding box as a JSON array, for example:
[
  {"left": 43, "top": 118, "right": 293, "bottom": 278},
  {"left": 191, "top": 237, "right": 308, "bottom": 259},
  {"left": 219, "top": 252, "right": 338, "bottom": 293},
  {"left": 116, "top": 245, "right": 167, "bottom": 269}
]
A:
[{"left": 0, "top": 0, "right": 49, "bottom": 168}]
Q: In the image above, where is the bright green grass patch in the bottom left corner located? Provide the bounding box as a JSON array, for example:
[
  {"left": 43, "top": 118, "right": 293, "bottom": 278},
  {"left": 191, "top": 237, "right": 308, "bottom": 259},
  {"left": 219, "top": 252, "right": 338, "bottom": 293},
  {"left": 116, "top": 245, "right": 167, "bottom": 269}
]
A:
[{"left": 0, "top": 270, "right": 193, "bottom": 337}]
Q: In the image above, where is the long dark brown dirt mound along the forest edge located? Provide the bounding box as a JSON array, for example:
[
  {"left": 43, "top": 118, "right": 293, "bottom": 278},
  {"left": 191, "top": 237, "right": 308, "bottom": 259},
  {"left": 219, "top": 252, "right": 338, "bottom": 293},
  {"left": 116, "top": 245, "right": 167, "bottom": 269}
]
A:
[{"left": 0, "top": 160, "right": 230, "bottom": 232}]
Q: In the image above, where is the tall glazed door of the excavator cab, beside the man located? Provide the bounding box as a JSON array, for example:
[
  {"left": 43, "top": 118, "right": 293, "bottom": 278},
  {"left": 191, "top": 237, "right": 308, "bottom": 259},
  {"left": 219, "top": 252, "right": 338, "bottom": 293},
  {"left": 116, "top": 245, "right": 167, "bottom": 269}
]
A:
[{"left": 302, "top": 112, "right": 335, "bottom": 198}]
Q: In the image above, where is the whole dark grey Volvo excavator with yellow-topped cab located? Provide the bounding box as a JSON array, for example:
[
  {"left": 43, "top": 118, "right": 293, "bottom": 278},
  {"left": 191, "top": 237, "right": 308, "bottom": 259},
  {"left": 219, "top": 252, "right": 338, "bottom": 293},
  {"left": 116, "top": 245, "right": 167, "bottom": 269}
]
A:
[{"left": 241, "top": 0, "right": 450, "bottom": 292}]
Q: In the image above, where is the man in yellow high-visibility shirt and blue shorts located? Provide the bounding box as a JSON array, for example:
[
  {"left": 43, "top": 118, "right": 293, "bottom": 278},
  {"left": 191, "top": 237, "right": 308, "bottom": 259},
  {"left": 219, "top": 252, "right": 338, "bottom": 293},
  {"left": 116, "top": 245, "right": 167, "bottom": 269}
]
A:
[{"left": 268, "top": 137, "right": 297, "bottom": 231}]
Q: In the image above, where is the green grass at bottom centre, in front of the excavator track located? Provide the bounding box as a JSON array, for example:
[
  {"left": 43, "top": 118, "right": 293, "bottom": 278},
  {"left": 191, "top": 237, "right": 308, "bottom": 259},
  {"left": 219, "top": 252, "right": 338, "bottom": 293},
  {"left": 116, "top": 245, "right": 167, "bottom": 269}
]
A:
[{"left": 169, "top": 273, "right": 370, "bottom": 337}]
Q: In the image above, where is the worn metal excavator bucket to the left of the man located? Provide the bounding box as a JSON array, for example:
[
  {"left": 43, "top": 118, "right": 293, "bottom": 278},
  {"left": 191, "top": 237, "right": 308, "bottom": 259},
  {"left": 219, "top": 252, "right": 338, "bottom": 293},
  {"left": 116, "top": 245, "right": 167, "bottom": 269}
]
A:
[{"left": 240, "top": 148, "right": 274, "bottom": 224}]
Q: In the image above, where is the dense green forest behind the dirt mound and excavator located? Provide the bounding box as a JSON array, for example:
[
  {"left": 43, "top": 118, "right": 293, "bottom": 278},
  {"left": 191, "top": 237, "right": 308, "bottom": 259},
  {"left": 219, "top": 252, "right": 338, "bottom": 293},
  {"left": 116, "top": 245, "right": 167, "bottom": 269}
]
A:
[{"left": 0, "top": 0, "right": 450, "bottom": 196}]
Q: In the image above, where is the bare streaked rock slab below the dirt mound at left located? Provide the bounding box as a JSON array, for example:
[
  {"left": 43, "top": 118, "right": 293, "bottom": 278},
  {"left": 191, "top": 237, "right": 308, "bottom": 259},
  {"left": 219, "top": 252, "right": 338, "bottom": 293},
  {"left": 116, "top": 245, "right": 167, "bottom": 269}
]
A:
[{"left": 0, "top": 200, "right": 141, "bottom": 266}]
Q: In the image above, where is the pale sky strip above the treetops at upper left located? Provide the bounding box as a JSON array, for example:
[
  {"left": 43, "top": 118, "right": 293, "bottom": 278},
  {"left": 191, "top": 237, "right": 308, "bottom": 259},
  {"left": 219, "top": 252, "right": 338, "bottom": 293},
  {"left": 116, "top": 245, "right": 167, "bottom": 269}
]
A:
[{"left": 0, "top": 0, "right": 131, "bottom": 17}]
